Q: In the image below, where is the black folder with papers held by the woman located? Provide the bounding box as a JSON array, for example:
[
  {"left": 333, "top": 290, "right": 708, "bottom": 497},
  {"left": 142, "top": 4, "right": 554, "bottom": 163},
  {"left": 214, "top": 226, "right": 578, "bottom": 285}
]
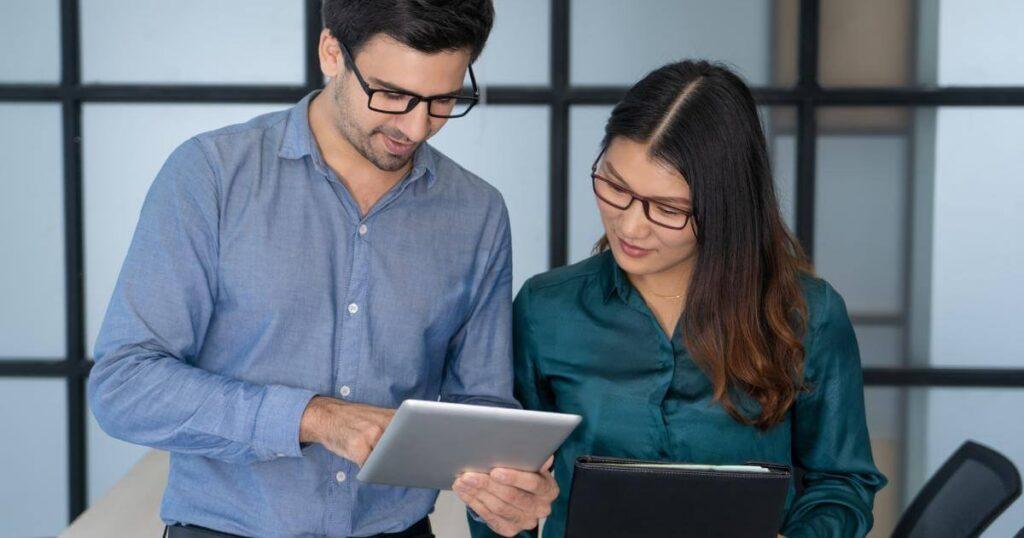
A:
[{"left": 565, "top": 456, "right": 792, "bottom": 538}]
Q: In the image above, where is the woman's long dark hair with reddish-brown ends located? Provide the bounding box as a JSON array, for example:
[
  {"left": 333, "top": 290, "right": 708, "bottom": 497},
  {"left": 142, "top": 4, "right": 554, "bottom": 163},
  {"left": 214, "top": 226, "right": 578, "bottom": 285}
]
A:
[{"left": 596, "top": 60, "right": 812, "bottom": 429}]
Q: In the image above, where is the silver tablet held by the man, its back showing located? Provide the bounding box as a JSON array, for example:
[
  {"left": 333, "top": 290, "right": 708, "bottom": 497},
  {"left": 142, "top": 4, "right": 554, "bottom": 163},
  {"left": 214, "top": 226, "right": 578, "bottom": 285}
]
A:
[{"left": 356, "top": 400, "right": 582, "bottom": 490}]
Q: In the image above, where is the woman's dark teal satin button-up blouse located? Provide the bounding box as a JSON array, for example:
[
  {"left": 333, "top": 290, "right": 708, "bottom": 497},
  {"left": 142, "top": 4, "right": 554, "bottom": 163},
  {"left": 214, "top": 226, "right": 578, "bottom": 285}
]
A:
[{"left": 470, "top": 252, "right": 886, "bottom": 538}]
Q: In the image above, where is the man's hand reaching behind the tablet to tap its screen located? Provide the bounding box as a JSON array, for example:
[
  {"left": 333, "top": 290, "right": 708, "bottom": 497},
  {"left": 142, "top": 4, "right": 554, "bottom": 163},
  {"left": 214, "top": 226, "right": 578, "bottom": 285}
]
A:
[{"left": 299, "top": 396, "right": 394, "bottom": 467}]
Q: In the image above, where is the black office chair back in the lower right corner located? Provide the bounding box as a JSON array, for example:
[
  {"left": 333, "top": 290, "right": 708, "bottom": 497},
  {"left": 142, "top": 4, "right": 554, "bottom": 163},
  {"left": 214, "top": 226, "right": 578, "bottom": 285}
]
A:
[{"left": 893, "top": 441, "right": 1021, "bottom": 538}]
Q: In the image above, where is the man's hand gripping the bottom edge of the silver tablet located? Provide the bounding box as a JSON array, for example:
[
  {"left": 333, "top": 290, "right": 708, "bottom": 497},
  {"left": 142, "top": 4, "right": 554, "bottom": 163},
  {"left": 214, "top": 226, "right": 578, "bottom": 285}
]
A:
[{"left": 452, "top": 457, "right": 558, "bottom": 536}]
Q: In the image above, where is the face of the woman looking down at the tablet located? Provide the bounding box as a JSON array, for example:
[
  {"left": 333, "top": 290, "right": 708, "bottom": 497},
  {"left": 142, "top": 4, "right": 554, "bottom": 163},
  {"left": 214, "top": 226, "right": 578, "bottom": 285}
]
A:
[{"left": 595, "top": 137, "right": 697, "bottom": 276}]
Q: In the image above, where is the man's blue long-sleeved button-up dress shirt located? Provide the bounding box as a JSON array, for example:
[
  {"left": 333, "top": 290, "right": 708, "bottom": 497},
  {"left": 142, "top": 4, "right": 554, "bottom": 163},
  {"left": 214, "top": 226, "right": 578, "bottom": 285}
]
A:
[{"left": 88, "top": 92, "right": 518, "bottom": 536}]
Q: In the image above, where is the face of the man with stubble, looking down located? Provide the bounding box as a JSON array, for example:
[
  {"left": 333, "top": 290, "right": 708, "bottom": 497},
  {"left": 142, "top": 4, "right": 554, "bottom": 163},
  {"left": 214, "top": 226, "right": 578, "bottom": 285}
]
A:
[{"left": 322, "top": 34, "right": 470, "bottom": 171}]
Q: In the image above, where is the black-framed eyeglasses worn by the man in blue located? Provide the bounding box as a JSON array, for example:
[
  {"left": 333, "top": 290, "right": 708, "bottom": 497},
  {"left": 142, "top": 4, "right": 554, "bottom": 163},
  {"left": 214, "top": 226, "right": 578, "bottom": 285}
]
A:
[{"left": 338, "top": 40, "right": 480, "bottom": 118}]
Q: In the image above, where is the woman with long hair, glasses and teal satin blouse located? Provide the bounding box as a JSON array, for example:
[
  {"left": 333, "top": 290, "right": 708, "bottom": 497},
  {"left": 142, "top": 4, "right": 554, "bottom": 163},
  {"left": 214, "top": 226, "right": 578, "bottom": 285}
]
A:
[{"left": 475, "top": 61, "right": 886, "bottom": 537}]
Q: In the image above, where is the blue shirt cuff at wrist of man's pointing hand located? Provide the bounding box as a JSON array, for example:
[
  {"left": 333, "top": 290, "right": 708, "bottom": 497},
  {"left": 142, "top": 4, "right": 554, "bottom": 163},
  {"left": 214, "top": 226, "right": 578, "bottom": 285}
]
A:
[{"left": 253, "top": 385, "right": 316, "bottom": 460}]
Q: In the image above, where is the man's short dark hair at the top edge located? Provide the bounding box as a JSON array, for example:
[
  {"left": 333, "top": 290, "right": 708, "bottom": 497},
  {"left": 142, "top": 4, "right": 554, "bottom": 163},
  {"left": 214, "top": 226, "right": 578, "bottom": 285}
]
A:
[{"left": 322, "top": 0, "right": 495, "bottom": 61}]
